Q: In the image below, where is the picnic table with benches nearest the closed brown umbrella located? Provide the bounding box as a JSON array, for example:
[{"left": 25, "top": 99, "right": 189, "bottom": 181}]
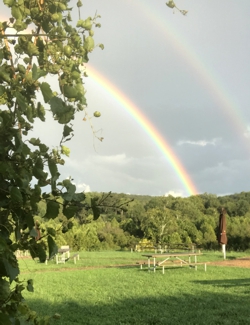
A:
[{"left": 141, "top": 252, "right": 207, "bottom": 274}]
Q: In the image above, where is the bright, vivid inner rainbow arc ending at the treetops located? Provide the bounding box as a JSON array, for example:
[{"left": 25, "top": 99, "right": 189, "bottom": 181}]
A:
[{"left": 86, "top": 64, "right": 198, "bottom": 195}]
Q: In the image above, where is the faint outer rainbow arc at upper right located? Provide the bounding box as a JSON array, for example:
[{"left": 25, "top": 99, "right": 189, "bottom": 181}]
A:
[{"left": 138, "top": 0, "right": 249, "bottom": 143}]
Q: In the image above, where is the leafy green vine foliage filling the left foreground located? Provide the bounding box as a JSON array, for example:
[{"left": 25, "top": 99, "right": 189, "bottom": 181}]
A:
[{"left": 0, "top": 0, "right": 103, "bottom": 325}]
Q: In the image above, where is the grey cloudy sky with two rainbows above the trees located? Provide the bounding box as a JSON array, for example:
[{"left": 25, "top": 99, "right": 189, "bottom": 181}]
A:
[{"left": 1, "top": 0, "right": 250, "bottom": 197}]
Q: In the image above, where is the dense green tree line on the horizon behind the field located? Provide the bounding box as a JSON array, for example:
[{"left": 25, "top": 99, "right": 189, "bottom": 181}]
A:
[{"left": 33, "top": 192, "right": 250, "bottom": 251}]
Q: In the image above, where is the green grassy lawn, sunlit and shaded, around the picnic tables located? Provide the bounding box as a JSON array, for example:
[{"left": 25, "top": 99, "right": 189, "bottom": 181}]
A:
[{"left": 20, "top": 252, "right": 250, "bottom": 325}]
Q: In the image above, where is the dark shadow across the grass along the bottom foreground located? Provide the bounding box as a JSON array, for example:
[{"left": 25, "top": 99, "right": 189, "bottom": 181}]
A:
[{"left": 25, "top": 288, "right": 250, "bottom": 325}]
